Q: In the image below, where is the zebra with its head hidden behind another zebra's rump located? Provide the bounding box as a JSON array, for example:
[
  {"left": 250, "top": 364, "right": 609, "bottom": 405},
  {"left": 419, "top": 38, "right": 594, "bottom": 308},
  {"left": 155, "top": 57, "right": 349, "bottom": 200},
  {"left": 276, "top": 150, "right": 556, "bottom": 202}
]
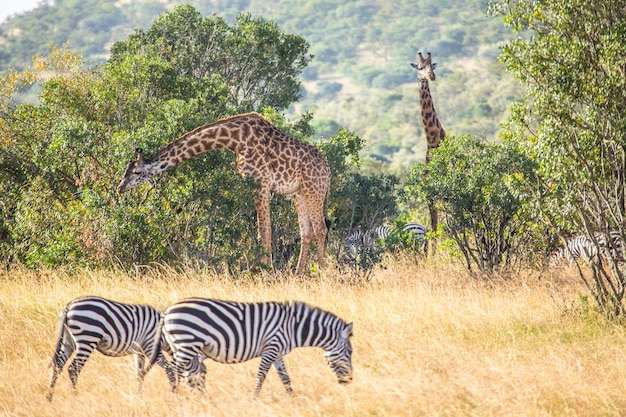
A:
[{"left": 47, "top": 297, "right": 175, "bottom": 401}]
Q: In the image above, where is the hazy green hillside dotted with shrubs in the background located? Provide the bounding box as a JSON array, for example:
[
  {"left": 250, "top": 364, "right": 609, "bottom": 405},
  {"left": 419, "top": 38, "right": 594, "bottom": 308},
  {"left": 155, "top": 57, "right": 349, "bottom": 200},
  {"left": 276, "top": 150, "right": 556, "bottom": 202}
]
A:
[{"left": 0, "top": 0, "right": 517, "bottom": 170}]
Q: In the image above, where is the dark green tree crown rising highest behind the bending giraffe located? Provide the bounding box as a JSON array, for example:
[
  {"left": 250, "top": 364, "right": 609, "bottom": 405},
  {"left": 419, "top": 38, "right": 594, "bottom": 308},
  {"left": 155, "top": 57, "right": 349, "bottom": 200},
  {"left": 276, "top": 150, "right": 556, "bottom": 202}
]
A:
[{"left": 110, "top": 5, "right": 312, "bottom": 112}]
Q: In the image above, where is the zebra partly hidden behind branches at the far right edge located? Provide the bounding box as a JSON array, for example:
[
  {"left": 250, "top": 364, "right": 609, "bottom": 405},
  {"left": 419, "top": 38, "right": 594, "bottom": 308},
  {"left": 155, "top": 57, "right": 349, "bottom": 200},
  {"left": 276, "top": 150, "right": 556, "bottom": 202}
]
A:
[{"left": 550, "top": 230, "right": 622, "bottom": 266}]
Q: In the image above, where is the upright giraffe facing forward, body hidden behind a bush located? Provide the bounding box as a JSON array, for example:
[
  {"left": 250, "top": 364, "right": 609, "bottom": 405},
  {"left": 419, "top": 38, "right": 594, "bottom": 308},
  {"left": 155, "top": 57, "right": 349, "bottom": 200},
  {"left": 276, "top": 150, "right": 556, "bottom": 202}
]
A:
[{"left": 411, "top": 52, "right": 446, "bottom": 250}]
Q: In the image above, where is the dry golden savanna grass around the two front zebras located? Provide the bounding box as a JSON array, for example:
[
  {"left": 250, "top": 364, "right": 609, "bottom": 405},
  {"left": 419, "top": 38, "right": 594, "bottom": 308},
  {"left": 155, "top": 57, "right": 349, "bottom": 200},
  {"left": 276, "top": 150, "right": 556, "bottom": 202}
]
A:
[{"left": 0, "top": 261, "right": 626, "bottom": 416}]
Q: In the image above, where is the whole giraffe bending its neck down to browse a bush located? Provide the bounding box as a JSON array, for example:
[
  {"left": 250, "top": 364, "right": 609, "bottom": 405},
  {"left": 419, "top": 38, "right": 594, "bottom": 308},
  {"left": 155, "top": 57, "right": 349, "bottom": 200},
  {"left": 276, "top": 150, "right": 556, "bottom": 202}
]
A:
[{"left": 117, "top": 113, "right": 330, "bottom": 274}]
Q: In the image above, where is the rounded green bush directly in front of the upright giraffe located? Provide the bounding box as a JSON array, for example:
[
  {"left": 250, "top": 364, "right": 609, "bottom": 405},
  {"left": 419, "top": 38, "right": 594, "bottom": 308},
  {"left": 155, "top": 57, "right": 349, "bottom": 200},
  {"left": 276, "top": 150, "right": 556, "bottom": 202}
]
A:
[{"left": 406, "top": 135, "right": 534, "bottom": 271}]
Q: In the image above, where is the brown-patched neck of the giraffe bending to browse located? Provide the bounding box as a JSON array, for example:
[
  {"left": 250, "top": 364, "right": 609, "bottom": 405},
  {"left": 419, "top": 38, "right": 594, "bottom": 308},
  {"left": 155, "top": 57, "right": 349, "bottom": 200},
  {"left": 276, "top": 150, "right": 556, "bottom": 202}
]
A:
[{"left": 150, "top": 119, "right": 245, "bottom": 175}]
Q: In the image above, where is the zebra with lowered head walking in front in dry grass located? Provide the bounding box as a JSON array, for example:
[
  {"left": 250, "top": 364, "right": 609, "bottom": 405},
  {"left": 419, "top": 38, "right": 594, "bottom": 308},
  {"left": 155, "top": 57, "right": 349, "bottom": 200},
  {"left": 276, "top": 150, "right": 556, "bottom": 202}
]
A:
[{"left": 148, "top": 298, "right": 352, "bottom": 397}]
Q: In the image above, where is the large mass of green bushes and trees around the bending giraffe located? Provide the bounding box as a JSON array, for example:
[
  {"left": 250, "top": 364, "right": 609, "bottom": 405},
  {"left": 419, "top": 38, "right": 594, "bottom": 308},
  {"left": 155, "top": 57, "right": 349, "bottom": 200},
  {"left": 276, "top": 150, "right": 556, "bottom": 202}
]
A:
[{"left": 0, "top": 6, "right": 312, "bottom": 273}]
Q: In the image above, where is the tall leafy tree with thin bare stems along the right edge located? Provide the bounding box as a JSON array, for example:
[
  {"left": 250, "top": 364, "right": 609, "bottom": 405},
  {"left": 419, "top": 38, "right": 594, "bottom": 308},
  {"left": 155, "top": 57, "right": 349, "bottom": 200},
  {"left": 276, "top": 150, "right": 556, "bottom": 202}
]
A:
[{"left": 490, "top": 0, "right": 626, "bottom": 316}]
